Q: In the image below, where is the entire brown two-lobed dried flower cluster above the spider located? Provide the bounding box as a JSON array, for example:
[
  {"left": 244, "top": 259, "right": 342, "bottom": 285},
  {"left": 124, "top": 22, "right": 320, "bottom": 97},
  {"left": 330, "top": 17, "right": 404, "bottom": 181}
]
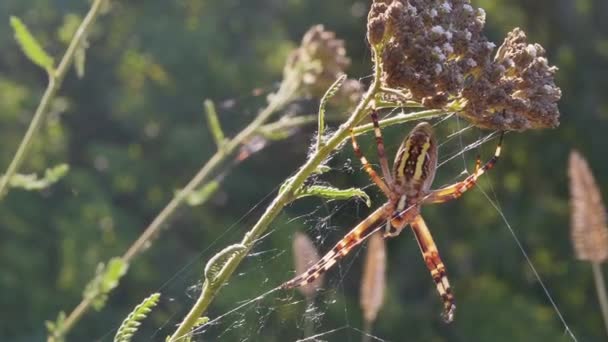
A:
[{"left": 367, "top": 0, "right": 561, "bottom": 130}]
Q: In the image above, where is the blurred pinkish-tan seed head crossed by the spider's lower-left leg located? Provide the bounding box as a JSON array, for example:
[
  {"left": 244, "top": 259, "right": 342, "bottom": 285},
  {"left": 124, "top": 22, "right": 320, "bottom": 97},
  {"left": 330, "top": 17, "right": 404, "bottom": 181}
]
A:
[{"left": 293, "top": 232, "right": 323, "bottom": 298}]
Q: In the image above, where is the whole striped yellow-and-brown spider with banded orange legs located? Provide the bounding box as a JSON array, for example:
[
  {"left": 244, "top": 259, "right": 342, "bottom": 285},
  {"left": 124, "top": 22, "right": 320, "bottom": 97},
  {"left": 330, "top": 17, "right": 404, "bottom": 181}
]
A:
[{"left": 281, "top": 111, "right": 502, "bottom": 322}]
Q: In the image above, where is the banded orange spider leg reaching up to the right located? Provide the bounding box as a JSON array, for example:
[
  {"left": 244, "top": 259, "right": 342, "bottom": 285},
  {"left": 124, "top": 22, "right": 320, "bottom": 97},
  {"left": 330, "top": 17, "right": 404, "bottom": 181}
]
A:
[{"left": 423, "top": 133, "right": 504, "bottom": 204}]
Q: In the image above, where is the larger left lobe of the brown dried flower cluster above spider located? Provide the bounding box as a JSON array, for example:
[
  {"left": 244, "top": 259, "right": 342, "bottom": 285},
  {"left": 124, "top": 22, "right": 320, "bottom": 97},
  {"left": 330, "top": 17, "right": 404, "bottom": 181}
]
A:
[{"left": 368, "top": 0, "right": 491, "bottom": 107}]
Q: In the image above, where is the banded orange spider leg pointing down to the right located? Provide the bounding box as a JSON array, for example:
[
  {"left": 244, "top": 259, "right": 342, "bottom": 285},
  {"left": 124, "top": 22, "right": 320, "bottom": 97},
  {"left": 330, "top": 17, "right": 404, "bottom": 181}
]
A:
[{"left": 411, "top": 215, "right": 456, "bottom": 323}]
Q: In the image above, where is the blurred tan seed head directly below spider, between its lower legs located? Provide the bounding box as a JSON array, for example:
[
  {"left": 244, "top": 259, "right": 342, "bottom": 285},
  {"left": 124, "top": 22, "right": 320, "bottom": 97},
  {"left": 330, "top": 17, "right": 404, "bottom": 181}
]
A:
[{"left": 360, "top": 233, "right": 386, "bottom": 323}]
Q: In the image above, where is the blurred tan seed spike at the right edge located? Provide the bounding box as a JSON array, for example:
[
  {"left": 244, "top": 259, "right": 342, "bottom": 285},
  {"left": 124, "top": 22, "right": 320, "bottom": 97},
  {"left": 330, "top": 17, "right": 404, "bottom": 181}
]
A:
[{"left": 568, "top": 151, "right": 608, "bottom": 263}]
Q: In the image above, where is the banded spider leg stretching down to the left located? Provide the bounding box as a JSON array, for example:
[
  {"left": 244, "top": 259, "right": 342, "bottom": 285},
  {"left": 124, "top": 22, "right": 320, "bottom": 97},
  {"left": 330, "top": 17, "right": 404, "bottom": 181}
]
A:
[{"left": 281, "top": 202, "right": 392, "bottom": 289}]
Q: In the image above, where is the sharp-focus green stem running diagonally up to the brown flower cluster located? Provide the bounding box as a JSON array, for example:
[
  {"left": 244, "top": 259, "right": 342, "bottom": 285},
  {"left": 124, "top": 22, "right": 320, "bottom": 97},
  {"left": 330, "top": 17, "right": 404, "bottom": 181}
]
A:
[{"left": 169, "top": 46, "right": 446, "bottom": 342}]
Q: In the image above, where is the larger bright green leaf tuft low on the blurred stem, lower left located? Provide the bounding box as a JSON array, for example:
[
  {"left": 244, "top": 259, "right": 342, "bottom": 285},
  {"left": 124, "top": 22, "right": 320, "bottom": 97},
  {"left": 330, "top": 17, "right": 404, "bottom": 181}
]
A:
[{"left": 84, "top": 258, "right": 128, "bottom": 310}]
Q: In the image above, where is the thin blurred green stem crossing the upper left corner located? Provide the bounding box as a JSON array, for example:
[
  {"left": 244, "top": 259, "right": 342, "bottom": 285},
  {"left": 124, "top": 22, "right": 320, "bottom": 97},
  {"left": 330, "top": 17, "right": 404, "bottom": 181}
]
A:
[{"left": 0, "top": 0, "right": 106, "bottom": 199}]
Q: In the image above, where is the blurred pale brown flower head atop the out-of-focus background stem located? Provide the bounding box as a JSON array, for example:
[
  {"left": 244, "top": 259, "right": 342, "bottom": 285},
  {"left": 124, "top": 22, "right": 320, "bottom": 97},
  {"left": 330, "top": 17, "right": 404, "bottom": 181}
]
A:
[{"left": 284, "top": 25, "right": 350, "bottom": 97}]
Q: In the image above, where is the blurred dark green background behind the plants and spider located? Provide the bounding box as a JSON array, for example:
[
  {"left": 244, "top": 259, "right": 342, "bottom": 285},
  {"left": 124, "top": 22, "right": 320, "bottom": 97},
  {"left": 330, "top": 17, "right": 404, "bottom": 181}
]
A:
[{"left": 0, "top": 0, "right": 608, "bottom": 341}]
